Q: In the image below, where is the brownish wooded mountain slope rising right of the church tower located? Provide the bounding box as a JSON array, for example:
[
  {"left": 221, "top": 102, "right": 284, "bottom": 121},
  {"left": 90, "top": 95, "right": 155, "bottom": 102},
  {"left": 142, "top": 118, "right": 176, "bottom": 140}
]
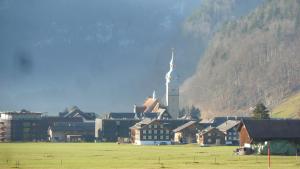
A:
[{"left": 181, "top": 0, "right": 300, "bottom": 116}]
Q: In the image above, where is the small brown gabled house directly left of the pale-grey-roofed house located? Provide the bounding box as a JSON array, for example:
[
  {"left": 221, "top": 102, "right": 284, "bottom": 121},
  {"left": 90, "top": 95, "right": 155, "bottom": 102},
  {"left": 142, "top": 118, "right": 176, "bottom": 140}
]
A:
[{"left": 197, "top": 127, "right": 225, "bottom": 146}]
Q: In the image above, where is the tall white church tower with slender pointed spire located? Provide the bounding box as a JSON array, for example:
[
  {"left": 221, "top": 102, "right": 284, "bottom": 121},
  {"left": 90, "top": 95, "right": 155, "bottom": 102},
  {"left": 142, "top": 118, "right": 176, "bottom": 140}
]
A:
[{"left": 166, "top": 49, "right": 179, "bottom": 119}]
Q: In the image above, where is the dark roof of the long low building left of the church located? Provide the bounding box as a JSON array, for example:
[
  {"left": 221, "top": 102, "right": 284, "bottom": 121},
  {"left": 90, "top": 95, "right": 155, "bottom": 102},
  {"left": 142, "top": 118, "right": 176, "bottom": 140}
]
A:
[{"left": 49, "top": 122, "right": 95, "bottom": 132}]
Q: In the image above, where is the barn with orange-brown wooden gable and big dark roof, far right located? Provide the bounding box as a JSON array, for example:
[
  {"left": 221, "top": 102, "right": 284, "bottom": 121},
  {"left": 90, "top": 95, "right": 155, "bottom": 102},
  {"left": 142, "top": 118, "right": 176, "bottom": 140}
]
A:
[{"left": 238, "top": 119, "right": 300, "bottom": 155}]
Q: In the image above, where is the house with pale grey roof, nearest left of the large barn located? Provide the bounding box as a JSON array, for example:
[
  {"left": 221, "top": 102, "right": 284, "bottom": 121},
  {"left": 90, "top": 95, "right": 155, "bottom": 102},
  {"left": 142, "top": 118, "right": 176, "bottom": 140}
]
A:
[{"left": 217, "top": 120, "right": 240, "bottom": 145}]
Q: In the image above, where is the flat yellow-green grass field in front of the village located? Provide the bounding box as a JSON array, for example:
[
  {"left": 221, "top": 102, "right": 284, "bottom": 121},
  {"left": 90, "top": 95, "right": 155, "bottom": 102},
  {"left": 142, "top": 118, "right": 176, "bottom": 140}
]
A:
[{"left": 0, "top": 143, "right": 300, "bottom": 169}]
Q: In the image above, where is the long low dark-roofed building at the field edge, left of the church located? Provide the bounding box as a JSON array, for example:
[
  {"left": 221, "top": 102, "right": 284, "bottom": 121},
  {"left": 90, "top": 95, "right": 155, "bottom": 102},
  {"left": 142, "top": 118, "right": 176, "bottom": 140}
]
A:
[{"left": 48, "top": 122, "right": 95, "bottom": 142}]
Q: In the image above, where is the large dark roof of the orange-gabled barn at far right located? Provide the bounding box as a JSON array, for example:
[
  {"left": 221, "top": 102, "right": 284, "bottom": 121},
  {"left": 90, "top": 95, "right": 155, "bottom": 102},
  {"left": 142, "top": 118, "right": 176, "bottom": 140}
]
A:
[{"left": 239, "top": 119, "right": 300, "bottom": 140}]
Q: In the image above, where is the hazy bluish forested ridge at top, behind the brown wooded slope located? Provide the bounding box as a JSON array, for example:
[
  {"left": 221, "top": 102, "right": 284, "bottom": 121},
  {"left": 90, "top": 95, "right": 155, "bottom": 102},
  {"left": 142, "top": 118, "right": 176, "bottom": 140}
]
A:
[{"left": 184, "top": 0, "right": 263, "bottom": 41}]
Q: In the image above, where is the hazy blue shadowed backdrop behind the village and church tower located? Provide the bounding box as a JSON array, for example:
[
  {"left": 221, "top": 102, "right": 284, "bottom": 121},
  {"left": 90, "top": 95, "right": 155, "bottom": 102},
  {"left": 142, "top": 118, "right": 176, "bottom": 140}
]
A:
[{"left": 0, "top": 0, "right": 199, "bottom": 114}]
